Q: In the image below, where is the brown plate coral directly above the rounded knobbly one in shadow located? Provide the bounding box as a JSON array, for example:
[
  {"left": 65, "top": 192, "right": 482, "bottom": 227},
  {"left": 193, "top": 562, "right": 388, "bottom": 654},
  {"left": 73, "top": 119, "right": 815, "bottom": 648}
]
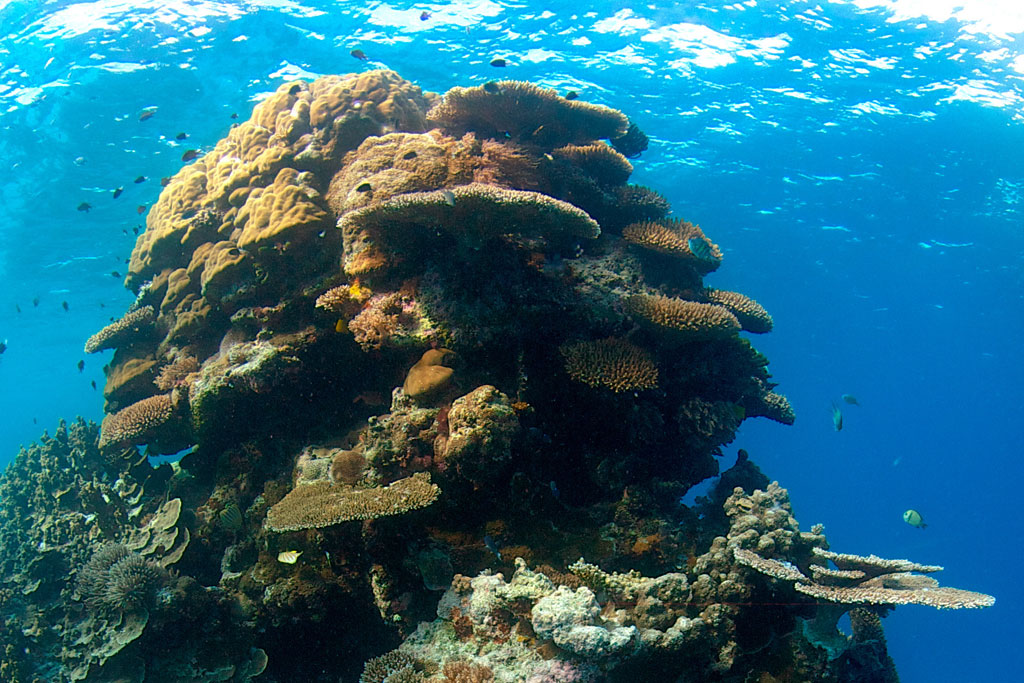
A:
[{"left": 626, "top": 294, "right": 740, "bottom": 341}]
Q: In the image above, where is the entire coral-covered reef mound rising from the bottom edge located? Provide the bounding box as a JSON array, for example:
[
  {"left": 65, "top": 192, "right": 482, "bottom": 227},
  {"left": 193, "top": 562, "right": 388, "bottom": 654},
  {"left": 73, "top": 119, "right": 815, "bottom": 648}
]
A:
[{"left": 0, "top": 71, "right": 991, "bottom": 683}]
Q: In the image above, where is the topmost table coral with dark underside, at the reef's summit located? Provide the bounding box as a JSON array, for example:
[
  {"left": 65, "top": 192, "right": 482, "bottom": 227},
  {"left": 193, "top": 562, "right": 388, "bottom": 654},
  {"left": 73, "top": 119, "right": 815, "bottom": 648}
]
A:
[{"left": 427, "top": 81, "right": 629, "bottom": 146}]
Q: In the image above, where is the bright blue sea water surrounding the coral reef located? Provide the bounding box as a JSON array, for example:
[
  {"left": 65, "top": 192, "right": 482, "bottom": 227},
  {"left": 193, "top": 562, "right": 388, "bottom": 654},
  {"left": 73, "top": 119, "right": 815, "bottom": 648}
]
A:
[{"left": 0, "top": 0, "right": 1024, "bottom": 683}]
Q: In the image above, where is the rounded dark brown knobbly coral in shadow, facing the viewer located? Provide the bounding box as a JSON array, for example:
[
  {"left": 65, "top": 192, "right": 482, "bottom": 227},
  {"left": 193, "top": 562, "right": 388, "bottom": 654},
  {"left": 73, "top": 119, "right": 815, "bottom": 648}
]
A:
[{"left": 559, "top": 337, "right": 657, "bottom": 393}]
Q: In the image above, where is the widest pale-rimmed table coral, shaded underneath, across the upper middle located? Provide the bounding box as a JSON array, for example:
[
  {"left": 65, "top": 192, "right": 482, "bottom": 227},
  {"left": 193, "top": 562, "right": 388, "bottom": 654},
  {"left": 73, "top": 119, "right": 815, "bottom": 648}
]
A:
[{"left": 340, "top": 183, "right": 601, "bottom": 275}]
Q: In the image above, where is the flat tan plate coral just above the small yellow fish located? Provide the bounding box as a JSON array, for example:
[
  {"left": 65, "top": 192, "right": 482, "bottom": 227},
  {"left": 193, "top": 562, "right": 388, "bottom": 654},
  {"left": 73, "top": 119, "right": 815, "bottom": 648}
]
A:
[{"left": 266, "top": 472, "right": 440, "bottom": 531}]
